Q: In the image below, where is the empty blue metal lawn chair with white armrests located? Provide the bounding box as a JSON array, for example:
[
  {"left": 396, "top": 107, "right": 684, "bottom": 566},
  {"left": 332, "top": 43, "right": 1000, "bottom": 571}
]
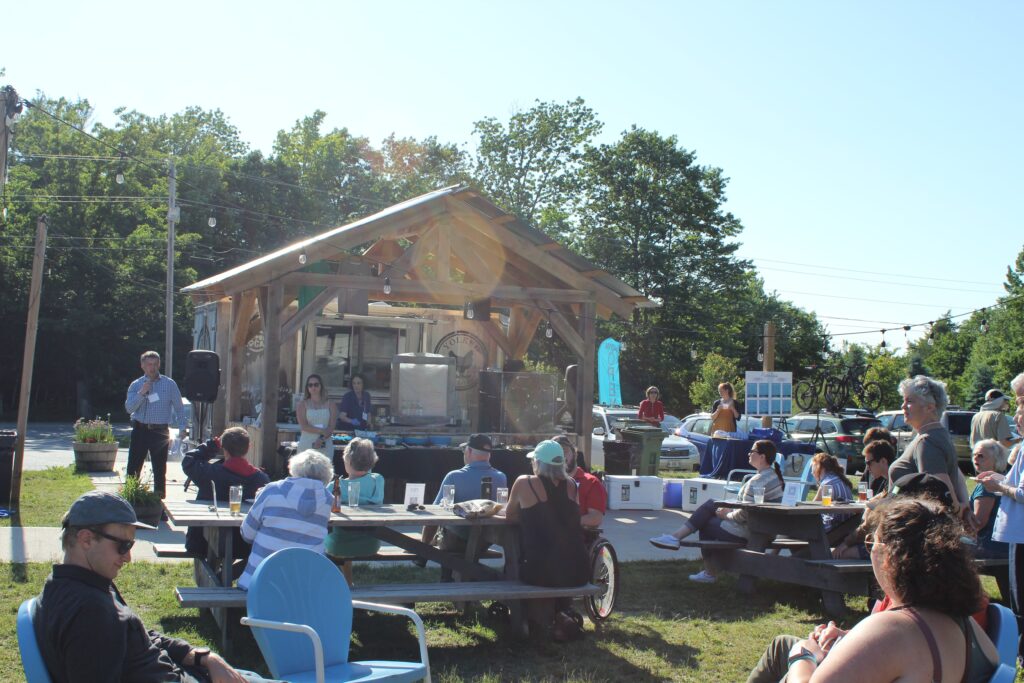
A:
[{"left": 242, "top": 548, "right": 430, "bottom": 683}]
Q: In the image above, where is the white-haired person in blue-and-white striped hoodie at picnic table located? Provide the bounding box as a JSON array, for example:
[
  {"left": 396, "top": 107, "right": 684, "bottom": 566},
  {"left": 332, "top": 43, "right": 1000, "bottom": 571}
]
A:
[{"left": 239, "top": 450, "right": 334, "bottom": 589}]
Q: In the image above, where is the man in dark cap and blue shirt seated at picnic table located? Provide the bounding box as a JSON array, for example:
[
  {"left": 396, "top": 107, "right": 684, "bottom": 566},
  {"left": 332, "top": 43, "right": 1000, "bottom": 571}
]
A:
[{"left": 414, "top": 434, "right": 508, "bottom": 578}]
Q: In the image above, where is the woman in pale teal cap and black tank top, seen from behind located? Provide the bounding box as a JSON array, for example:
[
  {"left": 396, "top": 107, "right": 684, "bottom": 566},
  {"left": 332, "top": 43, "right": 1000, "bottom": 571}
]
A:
[{"left": 505, "top": 441, "right": 590, "bottom": 641}]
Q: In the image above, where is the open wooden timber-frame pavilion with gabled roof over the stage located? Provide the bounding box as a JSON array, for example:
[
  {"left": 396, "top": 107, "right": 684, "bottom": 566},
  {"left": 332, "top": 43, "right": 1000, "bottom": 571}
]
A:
[{"left": 183, "top": 185, "right": 656, "bottom": 464}]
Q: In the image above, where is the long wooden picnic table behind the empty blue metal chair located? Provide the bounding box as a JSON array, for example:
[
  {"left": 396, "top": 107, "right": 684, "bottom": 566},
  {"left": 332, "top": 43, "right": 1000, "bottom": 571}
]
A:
[{"left": 164, "top": 501, "right": 599, "bottom": 646}]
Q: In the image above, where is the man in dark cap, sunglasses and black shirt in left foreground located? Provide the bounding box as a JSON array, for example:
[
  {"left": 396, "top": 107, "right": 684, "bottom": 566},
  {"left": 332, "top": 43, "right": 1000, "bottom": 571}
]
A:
[{"left": 32, "top": 490, "right": 278, "bottom": 683}]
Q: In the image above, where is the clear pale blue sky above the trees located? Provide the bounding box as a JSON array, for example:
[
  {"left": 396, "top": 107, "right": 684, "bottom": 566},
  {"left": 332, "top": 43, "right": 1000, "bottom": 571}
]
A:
[{"left": 0, "top": 0, "right": 1024, "bottom": 352}]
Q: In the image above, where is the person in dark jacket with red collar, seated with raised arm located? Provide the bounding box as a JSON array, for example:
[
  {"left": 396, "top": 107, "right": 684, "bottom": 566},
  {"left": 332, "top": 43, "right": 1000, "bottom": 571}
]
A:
[{"left": 181, "top": 427, "right": 270, "bottom": 567}]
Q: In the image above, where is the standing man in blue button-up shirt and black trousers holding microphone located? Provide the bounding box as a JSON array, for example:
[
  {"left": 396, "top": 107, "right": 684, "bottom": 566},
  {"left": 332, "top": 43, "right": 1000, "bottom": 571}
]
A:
[{"left": 125, "top": 351, "right": 188, "bottom": 498}]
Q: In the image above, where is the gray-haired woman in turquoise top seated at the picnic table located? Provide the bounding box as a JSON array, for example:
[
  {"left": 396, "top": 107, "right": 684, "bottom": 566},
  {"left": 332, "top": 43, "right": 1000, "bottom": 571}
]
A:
[{"left": 327, "top": 438, "right": 384, "bottom": 586}]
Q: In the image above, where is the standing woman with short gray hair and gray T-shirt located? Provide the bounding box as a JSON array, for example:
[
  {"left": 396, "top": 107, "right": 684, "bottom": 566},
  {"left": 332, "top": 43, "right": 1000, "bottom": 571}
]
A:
[{"left": 889, "top": 375, "right": 977, "bottom": 529}]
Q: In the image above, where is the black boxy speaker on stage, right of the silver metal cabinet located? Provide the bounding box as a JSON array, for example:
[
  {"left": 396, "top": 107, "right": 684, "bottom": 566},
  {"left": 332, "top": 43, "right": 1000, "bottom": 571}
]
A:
[{"left": 478, "top": 372, "right": 555, "bottom": 434}]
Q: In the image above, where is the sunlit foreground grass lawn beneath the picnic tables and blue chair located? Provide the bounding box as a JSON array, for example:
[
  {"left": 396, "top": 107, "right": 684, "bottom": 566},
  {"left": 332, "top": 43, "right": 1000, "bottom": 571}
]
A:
[{"left": 0, "top": 561, "right": 997, "bottom": 683}]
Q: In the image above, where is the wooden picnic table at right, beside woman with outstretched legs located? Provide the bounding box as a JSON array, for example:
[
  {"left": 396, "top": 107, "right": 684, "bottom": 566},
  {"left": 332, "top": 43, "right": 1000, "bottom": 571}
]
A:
[{"left": 708, "top": 501, "right": 871, "bottom": 617}]
